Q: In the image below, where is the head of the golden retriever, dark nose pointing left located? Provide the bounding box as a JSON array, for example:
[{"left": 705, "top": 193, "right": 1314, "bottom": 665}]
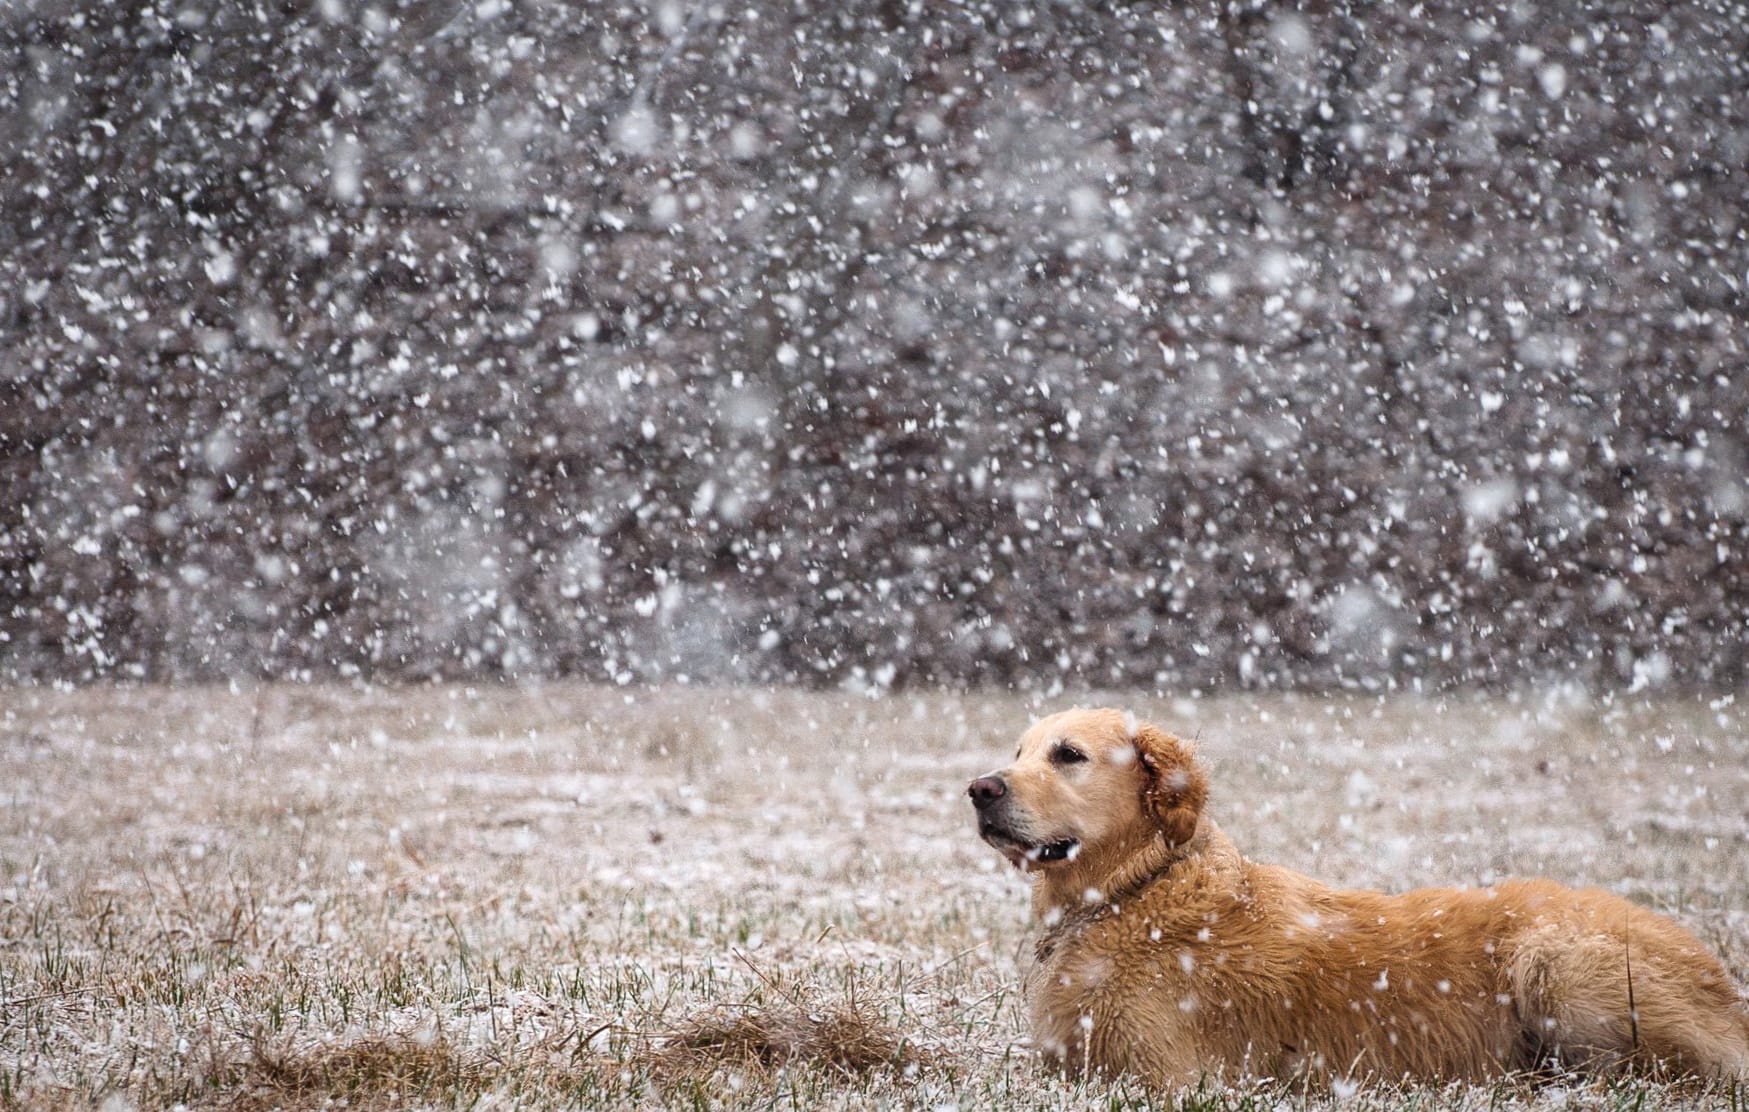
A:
[{"left": 967, "top": 710, "right": 1209, "bottom": 897}]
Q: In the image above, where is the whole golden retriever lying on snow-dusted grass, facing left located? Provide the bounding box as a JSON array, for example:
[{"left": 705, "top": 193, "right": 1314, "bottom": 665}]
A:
[{"left": 969, "top": 710, "right": 1749, "bottom": 1088}]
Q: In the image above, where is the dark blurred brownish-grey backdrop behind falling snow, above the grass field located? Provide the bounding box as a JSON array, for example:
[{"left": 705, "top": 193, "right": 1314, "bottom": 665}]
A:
[{"left": 0, "top": 0, "right": 1749, "bottom": 687}]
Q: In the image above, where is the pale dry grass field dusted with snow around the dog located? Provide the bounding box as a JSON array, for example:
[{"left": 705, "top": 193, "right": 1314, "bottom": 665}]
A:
[{"left": 0, "top": 687, "right": 1749, "bottom": 1109}]
